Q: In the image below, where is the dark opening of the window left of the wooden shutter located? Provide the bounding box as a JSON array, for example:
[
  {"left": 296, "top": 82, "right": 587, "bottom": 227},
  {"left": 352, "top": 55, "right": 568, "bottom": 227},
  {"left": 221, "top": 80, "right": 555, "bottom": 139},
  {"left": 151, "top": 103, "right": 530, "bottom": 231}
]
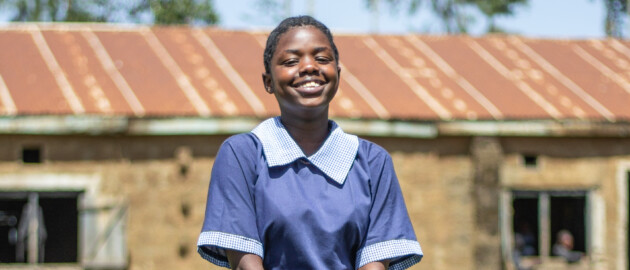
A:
[{"left": 0, "top": 192, "right": 79, "bottom": 263}]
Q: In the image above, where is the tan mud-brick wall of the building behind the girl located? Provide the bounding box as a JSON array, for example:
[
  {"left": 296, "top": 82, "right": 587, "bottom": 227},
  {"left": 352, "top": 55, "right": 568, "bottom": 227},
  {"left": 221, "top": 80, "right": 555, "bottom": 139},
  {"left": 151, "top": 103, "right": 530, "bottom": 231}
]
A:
[{"left": 0, "top": 135, "right": 630, "bottom": 270}]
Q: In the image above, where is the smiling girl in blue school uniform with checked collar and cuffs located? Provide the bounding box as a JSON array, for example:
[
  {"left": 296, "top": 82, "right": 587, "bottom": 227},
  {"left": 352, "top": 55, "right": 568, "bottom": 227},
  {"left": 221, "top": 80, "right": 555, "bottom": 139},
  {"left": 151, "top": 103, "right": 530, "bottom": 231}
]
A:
[{"left": 197, "top": 16, "right": 423, "bottom": 269}]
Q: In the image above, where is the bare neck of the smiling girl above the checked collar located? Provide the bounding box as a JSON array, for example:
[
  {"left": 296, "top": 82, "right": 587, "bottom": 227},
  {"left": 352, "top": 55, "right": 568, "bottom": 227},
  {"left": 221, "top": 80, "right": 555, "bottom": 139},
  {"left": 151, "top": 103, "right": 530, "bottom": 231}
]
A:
[{"left": 280, "top": 114, "right": 329, "bottom": 156}]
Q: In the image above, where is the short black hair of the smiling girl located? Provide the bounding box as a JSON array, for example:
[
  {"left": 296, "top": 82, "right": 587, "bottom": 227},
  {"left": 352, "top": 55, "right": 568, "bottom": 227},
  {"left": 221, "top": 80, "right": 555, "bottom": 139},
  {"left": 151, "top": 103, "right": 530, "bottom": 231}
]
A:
[{"left": 263, "top": 15, "right": 339, "bottom": 74}]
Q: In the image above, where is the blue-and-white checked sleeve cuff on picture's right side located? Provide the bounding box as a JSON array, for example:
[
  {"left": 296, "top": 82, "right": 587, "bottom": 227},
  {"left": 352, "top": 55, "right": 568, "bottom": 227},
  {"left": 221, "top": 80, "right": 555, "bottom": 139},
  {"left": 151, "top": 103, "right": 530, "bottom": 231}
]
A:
[{"left": 356, "top": 239, "right": 423, "bottom": 270}]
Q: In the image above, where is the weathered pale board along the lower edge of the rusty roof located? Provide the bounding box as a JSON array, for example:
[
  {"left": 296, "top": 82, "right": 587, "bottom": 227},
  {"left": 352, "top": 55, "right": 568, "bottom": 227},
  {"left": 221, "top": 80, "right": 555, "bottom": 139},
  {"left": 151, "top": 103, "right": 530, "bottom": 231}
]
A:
[{"left": 0, "top": 115, "right": 630, "bottom": 138}]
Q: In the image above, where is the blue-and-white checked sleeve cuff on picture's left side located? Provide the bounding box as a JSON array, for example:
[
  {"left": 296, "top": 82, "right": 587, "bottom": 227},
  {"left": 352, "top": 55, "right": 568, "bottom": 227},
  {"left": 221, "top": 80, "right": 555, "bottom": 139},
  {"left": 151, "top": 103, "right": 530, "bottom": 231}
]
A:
[{"left": 197, "top": 231, "right": 264, "bottom": 268}]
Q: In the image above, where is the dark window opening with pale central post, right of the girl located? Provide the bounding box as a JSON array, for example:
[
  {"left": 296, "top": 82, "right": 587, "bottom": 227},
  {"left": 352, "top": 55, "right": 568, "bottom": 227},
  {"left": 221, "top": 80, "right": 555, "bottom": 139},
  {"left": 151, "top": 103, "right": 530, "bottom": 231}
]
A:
[{"left": 511, "top": 190, "right": 588, "bottom": 257}]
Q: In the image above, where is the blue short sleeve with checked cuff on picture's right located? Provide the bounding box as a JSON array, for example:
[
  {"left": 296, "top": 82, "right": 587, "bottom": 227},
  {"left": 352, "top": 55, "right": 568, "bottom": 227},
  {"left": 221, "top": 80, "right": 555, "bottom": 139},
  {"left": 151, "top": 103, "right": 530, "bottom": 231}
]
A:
[{"left": 356, "top": 150, "right": 423, "bottom": 269}]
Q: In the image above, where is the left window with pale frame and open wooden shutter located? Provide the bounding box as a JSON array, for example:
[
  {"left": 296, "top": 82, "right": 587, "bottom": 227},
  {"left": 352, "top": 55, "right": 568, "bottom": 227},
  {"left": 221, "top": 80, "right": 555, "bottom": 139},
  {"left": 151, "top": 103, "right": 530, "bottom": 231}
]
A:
[{"left": 0, "top": 173, "right": 129, "bottom": 270}]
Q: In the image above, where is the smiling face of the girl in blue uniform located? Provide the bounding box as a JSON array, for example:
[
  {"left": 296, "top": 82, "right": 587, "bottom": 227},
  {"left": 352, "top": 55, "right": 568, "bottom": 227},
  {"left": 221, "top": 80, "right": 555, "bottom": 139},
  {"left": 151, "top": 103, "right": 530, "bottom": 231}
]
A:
[{"left": 263, "top": 26, "right": 340, "bottom": 116}]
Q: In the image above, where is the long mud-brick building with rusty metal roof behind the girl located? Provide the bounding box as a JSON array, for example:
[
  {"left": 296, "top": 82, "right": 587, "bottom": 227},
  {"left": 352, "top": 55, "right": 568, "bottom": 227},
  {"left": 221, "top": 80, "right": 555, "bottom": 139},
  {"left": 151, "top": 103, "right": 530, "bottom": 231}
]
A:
[{"left": 0, "top": 24, "right": 630, "bottom": 269}]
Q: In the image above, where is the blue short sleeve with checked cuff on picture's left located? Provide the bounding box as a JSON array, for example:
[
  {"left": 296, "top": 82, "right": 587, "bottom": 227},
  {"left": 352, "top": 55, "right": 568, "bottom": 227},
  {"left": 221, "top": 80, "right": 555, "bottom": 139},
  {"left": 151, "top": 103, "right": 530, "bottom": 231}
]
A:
[{"left": 197, "top": 139, "right": 263, "bottom": 267}]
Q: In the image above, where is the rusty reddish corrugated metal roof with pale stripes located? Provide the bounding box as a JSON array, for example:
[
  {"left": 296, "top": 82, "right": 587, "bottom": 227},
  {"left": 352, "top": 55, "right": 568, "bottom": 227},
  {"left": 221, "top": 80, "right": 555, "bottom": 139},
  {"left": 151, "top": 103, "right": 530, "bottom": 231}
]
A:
[{"left": 0, "top": 24, "right": 630, "bottom": 122}]
